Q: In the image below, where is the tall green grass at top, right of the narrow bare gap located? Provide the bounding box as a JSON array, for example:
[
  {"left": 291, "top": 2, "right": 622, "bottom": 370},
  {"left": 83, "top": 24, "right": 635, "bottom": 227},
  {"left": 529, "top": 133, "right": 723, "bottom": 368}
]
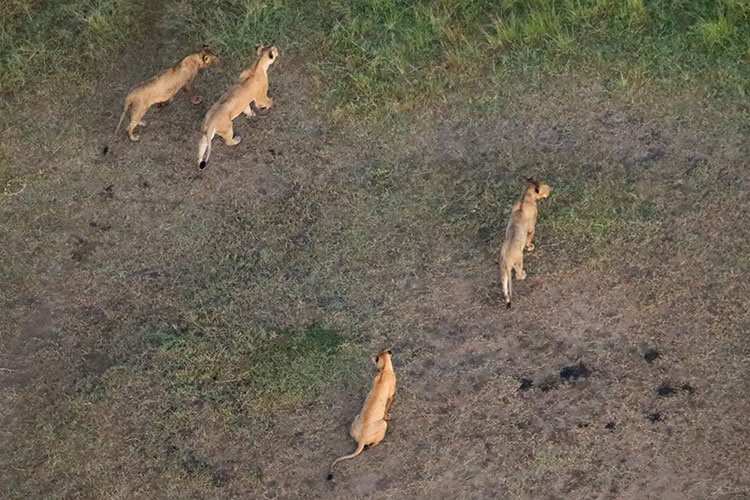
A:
[{"left": 170, "top": 0, "right": 750, "bottom": 117}]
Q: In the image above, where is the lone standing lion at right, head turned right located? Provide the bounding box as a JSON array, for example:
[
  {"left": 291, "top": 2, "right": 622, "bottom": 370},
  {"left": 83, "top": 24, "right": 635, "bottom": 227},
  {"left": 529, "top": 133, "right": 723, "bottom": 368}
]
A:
[{"left": 500, "top": 179, "right": 550, "bottom": 309}]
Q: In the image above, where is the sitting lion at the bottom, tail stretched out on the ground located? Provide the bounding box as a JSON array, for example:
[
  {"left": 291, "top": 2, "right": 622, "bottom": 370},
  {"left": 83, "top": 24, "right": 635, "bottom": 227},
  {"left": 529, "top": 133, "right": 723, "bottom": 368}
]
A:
[{"left": 328, "top": 350, "right": 396, "bottom": 479}]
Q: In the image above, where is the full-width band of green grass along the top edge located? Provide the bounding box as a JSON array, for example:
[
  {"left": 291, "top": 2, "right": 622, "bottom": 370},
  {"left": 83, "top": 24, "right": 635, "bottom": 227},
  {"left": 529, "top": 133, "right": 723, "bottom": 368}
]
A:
[{"left": 0, "top": 0, "right": 750, "bottom": 111}]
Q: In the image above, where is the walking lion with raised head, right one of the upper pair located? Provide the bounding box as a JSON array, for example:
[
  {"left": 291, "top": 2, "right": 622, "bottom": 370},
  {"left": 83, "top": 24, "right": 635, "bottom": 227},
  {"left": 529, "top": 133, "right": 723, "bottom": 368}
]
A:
[{"left": 198, "top": 45, "right": 279, "bottom": 168}]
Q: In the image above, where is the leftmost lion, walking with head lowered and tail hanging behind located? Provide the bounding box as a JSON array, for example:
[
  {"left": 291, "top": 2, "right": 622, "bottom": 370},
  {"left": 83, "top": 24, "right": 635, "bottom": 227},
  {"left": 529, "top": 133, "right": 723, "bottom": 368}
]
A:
[{"left": 110, "top": 45, "right": 219, "bottom": 146}]
